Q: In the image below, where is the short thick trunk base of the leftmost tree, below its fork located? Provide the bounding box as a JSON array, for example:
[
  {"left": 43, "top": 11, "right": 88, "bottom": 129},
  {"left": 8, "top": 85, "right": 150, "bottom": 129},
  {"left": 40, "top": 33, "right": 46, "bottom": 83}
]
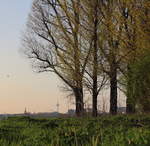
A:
[{"left": 74, "top": 88, "right": 84, "bottom": 117}]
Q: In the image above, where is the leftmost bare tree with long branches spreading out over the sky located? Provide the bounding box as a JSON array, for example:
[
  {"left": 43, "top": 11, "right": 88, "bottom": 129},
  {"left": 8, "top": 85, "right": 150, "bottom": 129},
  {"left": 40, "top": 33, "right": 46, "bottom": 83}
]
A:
[{"left": 23, "top": 0, "right": 91, "bottom": 116}]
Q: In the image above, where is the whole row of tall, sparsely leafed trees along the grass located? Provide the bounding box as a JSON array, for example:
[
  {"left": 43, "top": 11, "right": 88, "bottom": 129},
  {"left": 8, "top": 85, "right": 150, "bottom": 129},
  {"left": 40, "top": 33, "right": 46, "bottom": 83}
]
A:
[{"left": 23, "top": 0, "right": 150, "bottom": 116}]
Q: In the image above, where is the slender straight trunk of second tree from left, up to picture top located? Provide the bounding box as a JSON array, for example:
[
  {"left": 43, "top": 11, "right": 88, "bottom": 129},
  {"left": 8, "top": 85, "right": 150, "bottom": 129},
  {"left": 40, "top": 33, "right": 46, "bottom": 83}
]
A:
[{"left": 92, "top": 0, "right": 98, "bottom": 117}]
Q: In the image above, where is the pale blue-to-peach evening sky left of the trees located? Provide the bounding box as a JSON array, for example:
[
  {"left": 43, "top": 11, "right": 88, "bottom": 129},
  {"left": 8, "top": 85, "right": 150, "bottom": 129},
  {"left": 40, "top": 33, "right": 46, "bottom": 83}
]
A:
[{"left": 0, "top": 0, "right": 68, "bottom": 114}]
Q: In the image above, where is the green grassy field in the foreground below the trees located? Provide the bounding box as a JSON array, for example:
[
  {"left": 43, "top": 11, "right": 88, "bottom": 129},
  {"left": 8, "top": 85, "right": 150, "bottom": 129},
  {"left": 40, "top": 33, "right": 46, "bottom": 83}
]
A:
[{"left": 0, "top": 115, "right": 150, "bottom": 146}]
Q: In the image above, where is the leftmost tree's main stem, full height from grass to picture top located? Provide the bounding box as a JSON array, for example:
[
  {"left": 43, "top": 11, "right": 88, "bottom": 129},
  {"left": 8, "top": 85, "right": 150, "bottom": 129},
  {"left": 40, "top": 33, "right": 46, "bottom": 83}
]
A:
[{"left": 73, "top": 0, "right": 84, "bottom": 116}]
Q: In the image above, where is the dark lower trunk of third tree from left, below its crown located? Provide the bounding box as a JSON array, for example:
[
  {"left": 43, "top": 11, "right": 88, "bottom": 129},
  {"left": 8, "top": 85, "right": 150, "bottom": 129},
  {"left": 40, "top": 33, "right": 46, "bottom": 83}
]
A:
[{"left": 110, "top": 59, "right": 117, "bottom": 115}]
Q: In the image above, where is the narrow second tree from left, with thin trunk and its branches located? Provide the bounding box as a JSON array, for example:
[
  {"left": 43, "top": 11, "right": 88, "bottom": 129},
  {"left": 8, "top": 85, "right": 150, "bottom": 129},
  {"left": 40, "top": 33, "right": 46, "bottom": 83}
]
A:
[{"left": 75, "top": 0, "right": 107, "bottom": 117}]
